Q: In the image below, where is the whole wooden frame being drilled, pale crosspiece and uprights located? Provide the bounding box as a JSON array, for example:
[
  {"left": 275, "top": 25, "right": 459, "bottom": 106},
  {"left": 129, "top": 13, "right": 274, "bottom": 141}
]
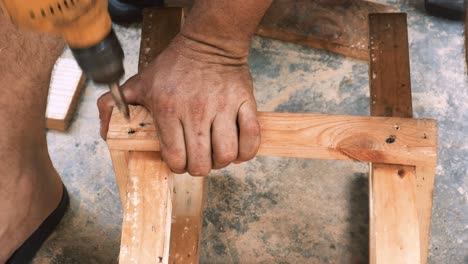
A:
[{"left": 107, "top": 8, "right": 437, "bottom": 263}]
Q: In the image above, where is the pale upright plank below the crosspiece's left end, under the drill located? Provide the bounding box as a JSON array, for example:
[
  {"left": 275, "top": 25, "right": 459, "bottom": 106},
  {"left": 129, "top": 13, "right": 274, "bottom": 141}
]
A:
[{"left": 119, "top": 152, "right": 173, "bottom": 263}]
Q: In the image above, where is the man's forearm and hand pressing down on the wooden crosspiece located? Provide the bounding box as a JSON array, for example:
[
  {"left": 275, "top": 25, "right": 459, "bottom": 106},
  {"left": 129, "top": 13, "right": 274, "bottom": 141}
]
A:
[{"left": 98, "top": 0, "right": 271, "bottom": 175}]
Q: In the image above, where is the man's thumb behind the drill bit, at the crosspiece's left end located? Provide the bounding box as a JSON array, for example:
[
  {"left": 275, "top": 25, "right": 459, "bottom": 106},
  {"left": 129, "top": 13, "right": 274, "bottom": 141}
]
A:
[{"left": 97, "top": 74, "right": 143, "bottom": 140}]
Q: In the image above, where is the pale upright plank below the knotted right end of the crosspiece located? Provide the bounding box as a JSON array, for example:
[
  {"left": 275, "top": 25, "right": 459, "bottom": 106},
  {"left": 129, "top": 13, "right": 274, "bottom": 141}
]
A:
[{"left": 371, "top": 163, "right": 421, "bottom": 264}]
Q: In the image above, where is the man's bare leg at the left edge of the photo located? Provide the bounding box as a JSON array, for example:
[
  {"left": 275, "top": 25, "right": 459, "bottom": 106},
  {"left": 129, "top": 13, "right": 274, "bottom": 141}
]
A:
[{"left": 0, "top": 12, "right": 63, "bottom": 263}]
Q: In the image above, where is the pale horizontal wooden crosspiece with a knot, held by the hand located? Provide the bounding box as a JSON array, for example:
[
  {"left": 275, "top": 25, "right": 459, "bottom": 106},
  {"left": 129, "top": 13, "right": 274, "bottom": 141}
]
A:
[{"left": 107, "top": 107, "right": 437, "bottom": 165}]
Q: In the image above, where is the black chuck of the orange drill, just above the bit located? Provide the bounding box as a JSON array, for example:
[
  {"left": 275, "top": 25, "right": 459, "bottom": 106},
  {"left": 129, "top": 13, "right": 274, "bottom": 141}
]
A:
[{"left": 70, "top": 30, "right": 124, "bottom": 84}]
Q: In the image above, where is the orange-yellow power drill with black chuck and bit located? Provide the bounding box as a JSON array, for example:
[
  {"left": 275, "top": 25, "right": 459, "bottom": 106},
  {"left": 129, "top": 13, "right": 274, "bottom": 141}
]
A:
[{"left": 0, "top": 0, "right": 130, "bottom": 119}]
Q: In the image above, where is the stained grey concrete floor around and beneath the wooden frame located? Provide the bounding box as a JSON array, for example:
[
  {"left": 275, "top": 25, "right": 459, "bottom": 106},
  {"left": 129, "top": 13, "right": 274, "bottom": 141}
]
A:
[{"left": 35, "top": 1, "right": 468, "bottom": 263}]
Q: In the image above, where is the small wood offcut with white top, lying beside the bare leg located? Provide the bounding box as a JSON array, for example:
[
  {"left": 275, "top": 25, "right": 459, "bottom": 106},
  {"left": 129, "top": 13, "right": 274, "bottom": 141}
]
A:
[{"left": 46, "top": 58, "right": 86, "bottom": 131}]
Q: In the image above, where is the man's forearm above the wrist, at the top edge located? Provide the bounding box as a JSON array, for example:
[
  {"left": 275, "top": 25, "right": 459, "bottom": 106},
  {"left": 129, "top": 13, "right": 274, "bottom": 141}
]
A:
[{"left": 182, "top": 0, "right": 272, "bottom": 57}]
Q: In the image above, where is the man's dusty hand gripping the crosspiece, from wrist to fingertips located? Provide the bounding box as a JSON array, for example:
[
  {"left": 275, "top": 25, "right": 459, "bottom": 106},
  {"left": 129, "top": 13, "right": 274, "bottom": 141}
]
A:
[{"left": 98, "top": 35, "right": 260, "bottom": 176}]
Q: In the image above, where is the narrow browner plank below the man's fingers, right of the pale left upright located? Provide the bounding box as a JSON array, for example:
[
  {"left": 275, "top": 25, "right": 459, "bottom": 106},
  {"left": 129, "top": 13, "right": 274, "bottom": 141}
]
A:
[{"left": 169, "top": 174, "right": 205, "bottom": 264}]
